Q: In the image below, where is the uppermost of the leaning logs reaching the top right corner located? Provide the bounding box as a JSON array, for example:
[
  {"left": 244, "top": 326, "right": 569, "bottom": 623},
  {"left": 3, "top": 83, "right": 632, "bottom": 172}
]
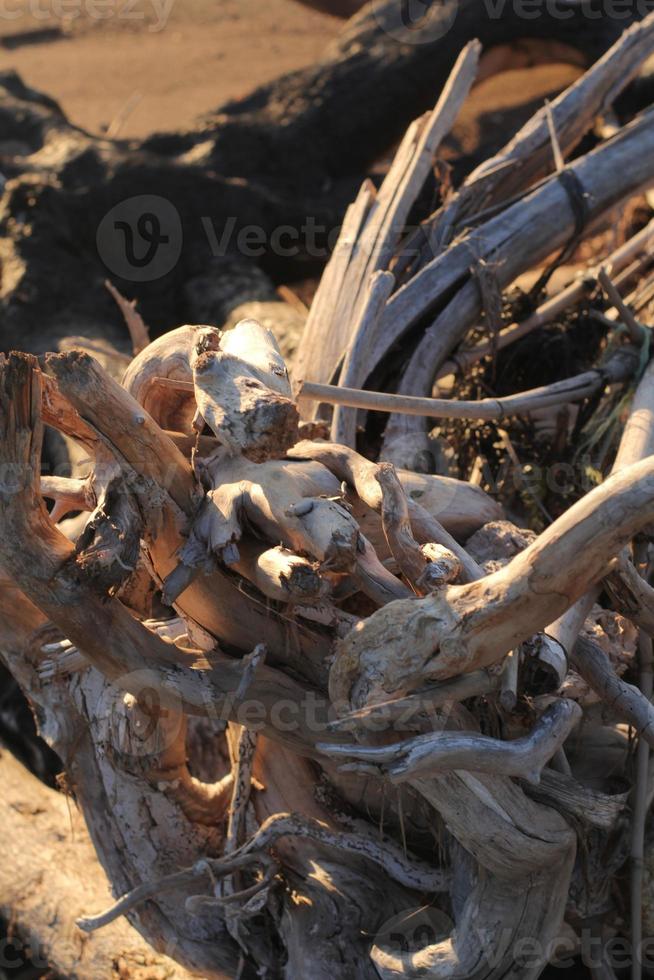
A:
[{"left": 407, "top": 15, "right": 654, "bottom": 270}]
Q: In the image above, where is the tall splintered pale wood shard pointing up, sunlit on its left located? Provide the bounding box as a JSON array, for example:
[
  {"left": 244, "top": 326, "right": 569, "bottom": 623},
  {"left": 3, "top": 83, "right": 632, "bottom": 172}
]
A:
[{"left": 294, "top": 41, "right": 481, "bottom": 418}]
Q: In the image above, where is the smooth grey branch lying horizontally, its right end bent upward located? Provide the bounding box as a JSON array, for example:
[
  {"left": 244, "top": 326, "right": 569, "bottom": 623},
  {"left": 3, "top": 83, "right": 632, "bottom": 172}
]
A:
[{"left": 317, "top": 699, "right": 582, "bottom": 783}]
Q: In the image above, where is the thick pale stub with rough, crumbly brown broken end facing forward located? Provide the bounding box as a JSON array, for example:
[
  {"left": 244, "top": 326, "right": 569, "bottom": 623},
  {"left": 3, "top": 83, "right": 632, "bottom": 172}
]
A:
[{"left": 191, "top": 320, "right": 299, "bottom": 462}]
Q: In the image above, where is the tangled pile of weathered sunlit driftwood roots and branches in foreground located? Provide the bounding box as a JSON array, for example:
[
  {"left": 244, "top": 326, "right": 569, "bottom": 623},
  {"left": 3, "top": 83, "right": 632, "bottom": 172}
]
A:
[{"left": 5, "top": 7, "right": 654, "bottom": 980}]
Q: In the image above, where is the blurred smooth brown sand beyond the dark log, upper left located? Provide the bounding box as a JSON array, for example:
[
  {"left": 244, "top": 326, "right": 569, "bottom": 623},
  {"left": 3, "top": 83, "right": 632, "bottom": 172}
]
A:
[{"left": 0, "top": 0, "right": 342, "bottom": 137}]
